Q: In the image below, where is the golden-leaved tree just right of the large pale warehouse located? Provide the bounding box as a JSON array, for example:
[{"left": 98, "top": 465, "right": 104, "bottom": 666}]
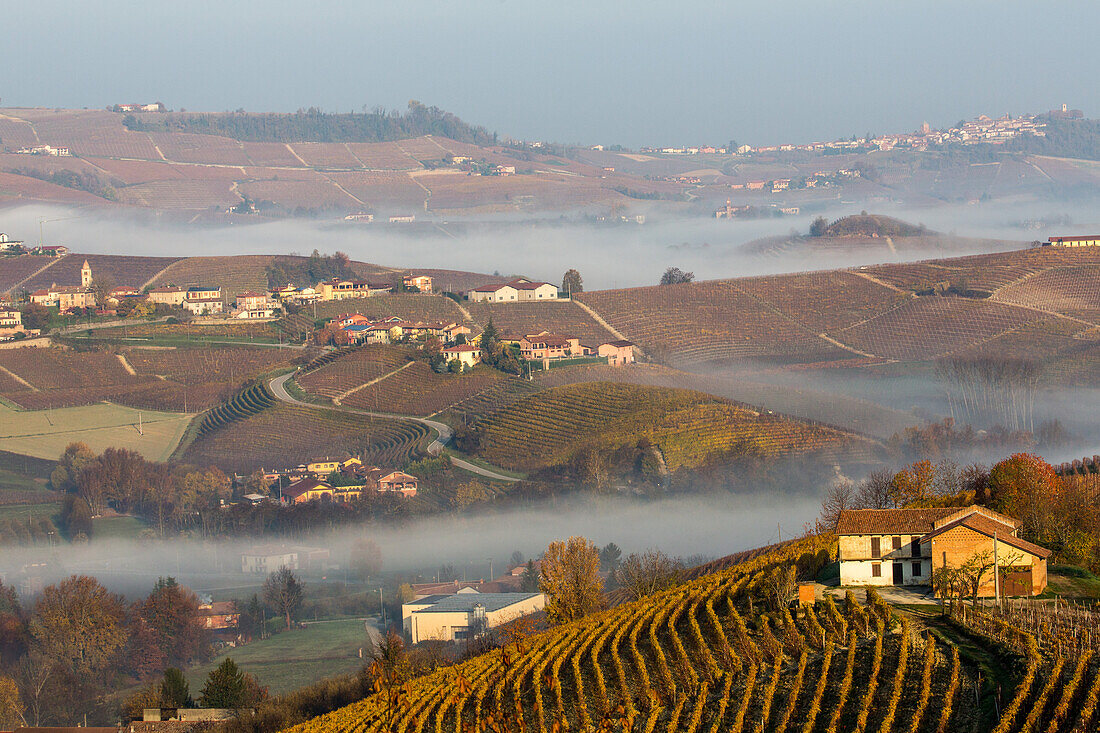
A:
[{"left": 539, "top": 537, "right": 604, "bottom": 623}]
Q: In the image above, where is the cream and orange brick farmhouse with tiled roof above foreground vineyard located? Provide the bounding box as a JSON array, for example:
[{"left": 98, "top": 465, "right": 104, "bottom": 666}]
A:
[{"left": 836, "top": 506, "right": 1051, "bottom": 595}]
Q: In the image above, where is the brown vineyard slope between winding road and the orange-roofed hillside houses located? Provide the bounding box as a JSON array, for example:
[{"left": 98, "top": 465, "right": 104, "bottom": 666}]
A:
[{"left": 343, "top": 361, "right": 512, "bottom": 416}]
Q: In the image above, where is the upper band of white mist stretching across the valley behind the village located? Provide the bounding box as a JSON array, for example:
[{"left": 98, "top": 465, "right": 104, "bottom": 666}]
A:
[{"left": 0, "top": 201, "right": 1096, "bottom": 289}]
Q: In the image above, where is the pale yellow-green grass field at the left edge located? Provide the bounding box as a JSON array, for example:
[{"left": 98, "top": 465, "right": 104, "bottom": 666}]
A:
[{"left": 0, "top": 404, "right": 194, "bottom": 461}]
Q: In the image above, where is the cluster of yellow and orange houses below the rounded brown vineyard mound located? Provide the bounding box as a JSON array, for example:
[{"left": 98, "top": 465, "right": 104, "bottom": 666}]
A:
[{"left": 251, "top": 456, "right": 418, "bottom": 504}]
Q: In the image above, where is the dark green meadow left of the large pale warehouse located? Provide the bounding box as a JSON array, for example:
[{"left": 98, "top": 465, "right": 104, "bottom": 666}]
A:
[{"left": 187, "top": 620, "right": 366, "bottom": 696}]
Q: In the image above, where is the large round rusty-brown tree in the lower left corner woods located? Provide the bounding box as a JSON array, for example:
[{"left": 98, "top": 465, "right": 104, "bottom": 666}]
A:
[{"left": 31, "top": 576, "right": 127, "bottom": 675}]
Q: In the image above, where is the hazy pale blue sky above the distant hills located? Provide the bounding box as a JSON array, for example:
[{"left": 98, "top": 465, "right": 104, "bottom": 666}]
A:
[{"left": 0, "top": 0, "right": 1100, "bottom": 147}]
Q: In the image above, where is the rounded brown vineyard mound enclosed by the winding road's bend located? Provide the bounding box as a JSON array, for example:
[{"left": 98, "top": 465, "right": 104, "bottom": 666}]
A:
[{"left": 182, "top": 403, "right": 430, "bottom": 473}]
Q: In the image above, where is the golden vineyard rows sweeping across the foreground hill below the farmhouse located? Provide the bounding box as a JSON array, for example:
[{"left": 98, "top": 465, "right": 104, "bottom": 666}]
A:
[{"left": 292, "top": 530, "right": 1100, "bottom": 733}]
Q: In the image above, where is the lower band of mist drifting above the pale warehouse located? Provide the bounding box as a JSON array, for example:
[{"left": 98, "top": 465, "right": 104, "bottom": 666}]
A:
[{"left": 0, "top": 486, "right": 820, "bottom": 597}]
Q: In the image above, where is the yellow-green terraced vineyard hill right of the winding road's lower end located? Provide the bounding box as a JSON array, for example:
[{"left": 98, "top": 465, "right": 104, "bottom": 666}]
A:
[{"left": 468, "top": 382, "right": 861, "bottom": 470}]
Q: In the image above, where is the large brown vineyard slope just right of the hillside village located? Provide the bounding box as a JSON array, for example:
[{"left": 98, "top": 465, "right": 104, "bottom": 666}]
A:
[{"left": 574, "top": 281, "right": 853, "bottom": 363}]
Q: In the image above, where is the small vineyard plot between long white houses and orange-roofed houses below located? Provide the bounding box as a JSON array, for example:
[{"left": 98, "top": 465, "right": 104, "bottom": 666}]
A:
[{"left": 465, "top": 300, "right": 615, "bottom": 347}]
